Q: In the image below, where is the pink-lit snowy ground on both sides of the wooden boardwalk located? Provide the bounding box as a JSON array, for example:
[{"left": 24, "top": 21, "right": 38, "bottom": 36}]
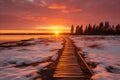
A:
[{"left": 0, "top": 36, "right": 120, "bottom": 80}]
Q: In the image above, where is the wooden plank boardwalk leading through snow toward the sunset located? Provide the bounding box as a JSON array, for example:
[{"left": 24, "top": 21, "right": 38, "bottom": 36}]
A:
[{"left": 53, "top": 37, "right": 91, "bottom": 80}]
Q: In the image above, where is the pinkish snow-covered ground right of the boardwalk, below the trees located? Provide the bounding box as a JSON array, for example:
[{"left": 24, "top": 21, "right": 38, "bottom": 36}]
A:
[{"left": 70, "top": 36, "right": 120, "bottom": 80}]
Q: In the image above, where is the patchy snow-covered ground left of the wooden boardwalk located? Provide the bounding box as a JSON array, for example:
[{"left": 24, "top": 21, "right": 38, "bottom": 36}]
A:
[{"left": 0, "top": 38, "right": 63, "bottom": 80}]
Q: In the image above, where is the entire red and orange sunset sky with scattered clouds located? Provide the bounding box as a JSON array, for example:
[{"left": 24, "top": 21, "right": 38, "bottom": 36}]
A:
[{"left": 0, "top": 0, "right": 120, "bottom": 32}]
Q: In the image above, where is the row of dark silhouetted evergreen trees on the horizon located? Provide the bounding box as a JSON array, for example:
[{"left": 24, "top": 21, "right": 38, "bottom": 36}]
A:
[{"left": 71, "top": 21, "right": 120, "bottom": 35}]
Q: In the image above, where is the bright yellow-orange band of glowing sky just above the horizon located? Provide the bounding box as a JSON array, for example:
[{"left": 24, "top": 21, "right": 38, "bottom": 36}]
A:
[{"left": 0, "top": 25, "right": 70, "bottom": 33}]
